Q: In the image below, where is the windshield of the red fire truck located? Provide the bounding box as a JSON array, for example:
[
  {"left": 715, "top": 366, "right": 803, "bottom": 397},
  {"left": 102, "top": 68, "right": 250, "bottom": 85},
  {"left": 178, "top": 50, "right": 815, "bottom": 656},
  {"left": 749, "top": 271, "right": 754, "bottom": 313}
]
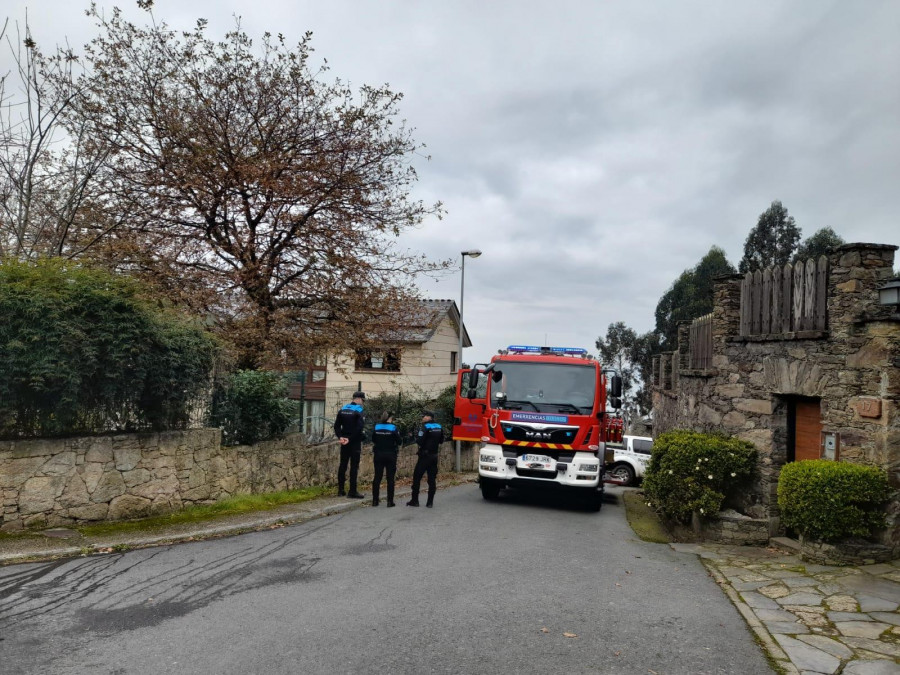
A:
[{"left": 491, "top": 361, "right": 596, "bottom": 415}]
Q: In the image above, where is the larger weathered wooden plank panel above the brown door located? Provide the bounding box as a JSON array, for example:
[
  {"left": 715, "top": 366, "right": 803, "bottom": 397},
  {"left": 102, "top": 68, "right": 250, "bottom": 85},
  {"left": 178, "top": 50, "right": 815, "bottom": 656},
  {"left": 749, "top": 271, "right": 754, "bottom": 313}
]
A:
[{"left": 741, "top": 255, "right": 828, "bottom": 336}]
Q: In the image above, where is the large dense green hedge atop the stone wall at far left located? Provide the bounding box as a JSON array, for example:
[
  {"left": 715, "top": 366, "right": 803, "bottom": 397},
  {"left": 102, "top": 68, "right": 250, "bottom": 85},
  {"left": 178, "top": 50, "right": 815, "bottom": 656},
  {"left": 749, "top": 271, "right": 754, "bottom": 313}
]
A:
[{"left": 0, "top": 259, "right": 218, "bottom": 437}]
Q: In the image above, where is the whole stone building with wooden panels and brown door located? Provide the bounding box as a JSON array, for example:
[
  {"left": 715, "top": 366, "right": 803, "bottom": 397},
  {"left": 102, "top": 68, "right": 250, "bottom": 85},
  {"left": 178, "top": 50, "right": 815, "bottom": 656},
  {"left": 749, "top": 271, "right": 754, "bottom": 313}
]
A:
[{"left": 653, "top": 244, "right": 900, "bottom": 553}]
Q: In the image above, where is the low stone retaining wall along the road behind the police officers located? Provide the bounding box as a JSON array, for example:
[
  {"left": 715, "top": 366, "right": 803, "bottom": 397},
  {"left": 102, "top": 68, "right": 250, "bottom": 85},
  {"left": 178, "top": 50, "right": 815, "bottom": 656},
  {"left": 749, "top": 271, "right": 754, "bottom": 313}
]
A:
[{"left": 0, "top": 429, "right": 476, "bottom": 532}]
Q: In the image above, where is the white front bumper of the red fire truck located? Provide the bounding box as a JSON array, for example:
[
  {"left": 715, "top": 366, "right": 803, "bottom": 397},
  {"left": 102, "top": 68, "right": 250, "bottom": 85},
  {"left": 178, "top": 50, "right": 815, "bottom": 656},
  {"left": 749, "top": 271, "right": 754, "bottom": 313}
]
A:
[{"left": 478, "top": 445, "right": 602, "bottom": 489}]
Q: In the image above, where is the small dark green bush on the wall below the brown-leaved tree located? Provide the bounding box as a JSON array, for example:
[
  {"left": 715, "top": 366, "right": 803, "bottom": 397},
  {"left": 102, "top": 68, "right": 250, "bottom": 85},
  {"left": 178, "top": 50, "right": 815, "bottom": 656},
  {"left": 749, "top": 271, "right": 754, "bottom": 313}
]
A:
[{"left": 210, "top": 370, "right": 295, "bottom": 445}]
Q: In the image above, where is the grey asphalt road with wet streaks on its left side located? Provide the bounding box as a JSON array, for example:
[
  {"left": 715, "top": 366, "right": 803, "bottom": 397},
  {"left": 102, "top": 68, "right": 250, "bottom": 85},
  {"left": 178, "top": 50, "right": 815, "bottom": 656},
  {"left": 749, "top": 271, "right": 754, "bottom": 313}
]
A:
[{"left": 0, "top": 485, "right": 772, "bottom": 675}]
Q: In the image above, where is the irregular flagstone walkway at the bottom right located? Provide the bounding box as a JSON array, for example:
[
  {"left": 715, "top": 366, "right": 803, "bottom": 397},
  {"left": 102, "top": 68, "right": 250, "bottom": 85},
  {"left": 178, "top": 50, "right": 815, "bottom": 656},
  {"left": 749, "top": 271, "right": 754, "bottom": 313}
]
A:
[{"left": 671, "top": 544, "right": 900, "bottom": 675}]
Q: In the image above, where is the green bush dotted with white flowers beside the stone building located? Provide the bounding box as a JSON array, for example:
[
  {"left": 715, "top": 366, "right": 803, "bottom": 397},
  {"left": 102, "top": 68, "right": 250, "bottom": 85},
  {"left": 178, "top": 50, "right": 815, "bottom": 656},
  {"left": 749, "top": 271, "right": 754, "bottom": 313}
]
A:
[{"left": 644, "top": 430, "right": 756, "bottom": 524}]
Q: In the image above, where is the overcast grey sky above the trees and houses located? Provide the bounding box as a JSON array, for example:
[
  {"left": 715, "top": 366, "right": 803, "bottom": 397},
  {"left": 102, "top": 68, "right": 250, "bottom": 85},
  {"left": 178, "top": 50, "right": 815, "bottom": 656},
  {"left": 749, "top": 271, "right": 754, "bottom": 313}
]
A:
[{"left": 0, "top": 0, "right": 900, "bottom": 361}]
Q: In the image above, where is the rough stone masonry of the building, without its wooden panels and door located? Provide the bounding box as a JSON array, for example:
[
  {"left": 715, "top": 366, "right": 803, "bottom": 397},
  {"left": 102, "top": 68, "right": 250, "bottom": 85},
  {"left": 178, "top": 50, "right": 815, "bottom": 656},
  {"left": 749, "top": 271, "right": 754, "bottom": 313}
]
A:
[{"left": 653, "top": 244, "right": 900, "bottom": 550}]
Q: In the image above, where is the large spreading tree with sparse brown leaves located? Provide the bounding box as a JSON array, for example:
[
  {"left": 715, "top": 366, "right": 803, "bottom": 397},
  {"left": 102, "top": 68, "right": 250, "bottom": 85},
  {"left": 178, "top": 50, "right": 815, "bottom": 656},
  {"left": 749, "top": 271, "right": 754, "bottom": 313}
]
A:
[{"left": 66, "top": 0, "right": 447, "bottom": 365}]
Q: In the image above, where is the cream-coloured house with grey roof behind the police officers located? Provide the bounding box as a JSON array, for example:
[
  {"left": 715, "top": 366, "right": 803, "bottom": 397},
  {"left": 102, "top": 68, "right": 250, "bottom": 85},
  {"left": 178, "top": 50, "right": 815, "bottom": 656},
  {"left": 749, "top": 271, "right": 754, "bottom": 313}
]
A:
[{"left": 325, "top": 300, "right": 472, "bottom": 415}]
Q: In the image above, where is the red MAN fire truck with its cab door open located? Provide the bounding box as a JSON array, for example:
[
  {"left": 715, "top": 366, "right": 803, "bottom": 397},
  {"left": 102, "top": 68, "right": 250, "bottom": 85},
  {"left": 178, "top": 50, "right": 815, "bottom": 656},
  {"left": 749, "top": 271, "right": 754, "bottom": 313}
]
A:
[{"left": 453, "top": 345, "right": 622, "bottom": 511}]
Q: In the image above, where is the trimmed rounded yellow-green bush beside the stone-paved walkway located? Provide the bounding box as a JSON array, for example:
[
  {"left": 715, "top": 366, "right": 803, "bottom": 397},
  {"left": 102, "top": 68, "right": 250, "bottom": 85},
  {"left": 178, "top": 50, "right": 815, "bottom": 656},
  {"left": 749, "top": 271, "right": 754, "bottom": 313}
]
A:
[{"left": 778, "top": 459, "right": 890, "bottom": 541}]
